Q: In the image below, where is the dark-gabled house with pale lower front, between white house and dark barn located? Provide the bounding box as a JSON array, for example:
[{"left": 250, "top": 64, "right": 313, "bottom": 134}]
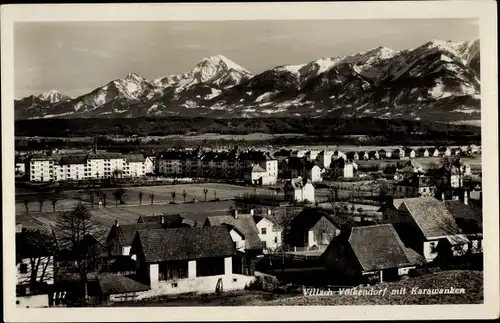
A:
[{"left": 286, "top": 208, "right": 340, "bottom": 251}]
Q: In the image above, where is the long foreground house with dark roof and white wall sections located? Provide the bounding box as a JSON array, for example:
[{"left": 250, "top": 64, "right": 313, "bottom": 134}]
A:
[{"left": 130, "top": 225, "right": 254, "bottom": 297}]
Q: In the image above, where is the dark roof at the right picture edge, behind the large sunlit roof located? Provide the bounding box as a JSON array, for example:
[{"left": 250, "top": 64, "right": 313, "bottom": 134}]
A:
[{"left": 445, "top": 201, "right": 483, "bottom": 234}]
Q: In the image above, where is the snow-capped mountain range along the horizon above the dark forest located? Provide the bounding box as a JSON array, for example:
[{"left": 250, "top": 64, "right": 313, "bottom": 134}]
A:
[{"left": 15, "top": 40, "right": 481, "bottom": 121}]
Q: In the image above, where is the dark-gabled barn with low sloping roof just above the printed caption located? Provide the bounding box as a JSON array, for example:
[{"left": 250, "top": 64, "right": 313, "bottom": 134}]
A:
[{"left": 321, "top": 224, "right": 424, "bottom": 283}]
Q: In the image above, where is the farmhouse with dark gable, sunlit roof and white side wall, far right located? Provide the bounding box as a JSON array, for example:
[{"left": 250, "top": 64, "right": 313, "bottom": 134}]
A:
[{"left": 392, "top": 197, "right": 470, "bottom": 261}]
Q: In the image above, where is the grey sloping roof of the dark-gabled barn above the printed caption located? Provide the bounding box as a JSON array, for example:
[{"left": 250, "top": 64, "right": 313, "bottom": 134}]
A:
[{"left": 348, "top": 224, "right": 421, "bottom": 271}]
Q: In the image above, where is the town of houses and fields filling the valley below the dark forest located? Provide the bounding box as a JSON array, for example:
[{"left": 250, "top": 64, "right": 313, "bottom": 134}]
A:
[{"left": 15, "top": 140, "right": 483, "bottom": 307}]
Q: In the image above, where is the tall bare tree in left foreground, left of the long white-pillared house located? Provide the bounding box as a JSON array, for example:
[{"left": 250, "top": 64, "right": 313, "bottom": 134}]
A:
[{"left": 54, "top": 203, "right": 106, "bottom": 306}]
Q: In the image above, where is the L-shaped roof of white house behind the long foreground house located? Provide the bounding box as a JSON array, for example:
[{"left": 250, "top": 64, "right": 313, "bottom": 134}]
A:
[{"left": 206, "top": 214, "right": 262, "bottom": 250}]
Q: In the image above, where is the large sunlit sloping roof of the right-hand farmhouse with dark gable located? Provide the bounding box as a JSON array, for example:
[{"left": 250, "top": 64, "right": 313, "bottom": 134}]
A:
[{"left": 399, "top": 197, "right": 462, "bottom": 238}]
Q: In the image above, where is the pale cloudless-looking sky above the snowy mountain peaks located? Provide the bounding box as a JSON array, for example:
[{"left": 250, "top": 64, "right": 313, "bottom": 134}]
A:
[{"left": 14, "top": 19, "right": 479, "bottom": 98}]
